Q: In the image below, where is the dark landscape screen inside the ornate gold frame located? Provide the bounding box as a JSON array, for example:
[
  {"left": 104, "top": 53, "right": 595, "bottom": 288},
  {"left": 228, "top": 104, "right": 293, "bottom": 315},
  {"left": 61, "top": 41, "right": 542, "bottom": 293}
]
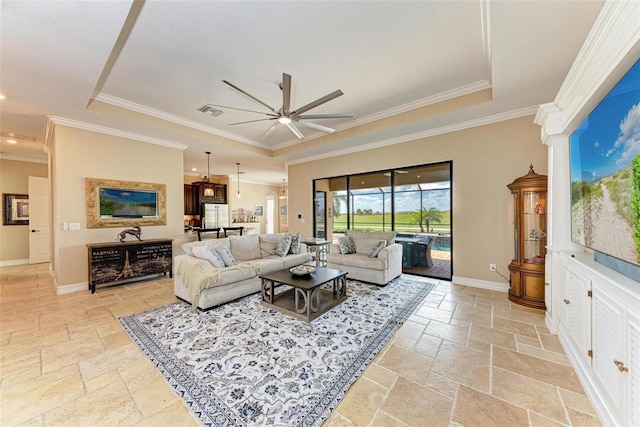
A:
[{"left": 99, "top": 188, "right": 158, "bottom": 218}]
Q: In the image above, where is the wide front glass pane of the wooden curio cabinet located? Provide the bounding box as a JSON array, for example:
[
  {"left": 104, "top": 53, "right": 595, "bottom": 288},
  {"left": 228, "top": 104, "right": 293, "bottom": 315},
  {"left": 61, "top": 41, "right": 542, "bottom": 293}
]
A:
[{"left": 522, "top": 191, "right": 547, "bottom": 264}]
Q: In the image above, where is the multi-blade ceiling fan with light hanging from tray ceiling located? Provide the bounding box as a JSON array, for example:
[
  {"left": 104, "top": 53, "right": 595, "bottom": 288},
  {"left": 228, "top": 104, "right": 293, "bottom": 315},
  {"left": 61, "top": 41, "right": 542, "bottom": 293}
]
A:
[{"left": 209, "top": 73, "right": 353, "bottom": 138}]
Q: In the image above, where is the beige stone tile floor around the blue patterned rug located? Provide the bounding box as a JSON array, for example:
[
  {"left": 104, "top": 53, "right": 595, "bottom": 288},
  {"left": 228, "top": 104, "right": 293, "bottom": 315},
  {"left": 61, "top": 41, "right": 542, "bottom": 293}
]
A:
[{"left": 0, "top": 264, "right": 600, "bottom": 427}]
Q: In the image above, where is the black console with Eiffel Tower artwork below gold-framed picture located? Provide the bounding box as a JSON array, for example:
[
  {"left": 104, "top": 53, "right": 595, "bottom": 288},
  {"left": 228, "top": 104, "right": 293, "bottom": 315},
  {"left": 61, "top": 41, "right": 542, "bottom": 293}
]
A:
[{"left": 87, "top": 239, "right": 173, "bottom": 294}]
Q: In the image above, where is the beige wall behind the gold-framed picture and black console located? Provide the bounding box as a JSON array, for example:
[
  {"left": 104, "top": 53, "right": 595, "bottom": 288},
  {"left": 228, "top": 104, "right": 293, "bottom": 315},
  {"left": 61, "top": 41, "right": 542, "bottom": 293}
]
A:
[{"left": 50, "top": 125, "right": 184, "bottom": 286}]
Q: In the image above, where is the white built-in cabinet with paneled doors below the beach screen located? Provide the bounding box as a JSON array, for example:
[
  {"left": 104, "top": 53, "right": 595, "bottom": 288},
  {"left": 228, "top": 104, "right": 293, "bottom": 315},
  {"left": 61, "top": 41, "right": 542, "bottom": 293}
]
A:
[{"left": 554, "top": 252, "right": 640, "bottom": 426}]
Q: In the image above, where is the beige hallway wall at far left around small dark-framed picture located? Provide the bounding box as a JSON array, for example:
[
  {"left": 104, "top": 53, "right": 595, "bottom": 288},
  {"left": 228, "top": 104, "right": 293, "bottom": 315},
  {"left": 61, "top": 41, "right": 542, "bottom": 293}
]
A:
[{"left": 0, "top": 160, "right": 48, "bottom": 265}]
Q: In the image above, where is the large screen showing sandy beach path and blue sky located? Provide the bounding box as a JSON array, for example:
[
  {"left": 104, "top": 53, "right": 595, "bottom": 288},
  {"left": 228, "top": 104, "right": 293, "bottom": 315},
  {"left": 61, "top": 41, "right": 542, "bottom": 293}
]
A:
[{"left": 570, "top": 61, "right": 640, "bottom": 265}]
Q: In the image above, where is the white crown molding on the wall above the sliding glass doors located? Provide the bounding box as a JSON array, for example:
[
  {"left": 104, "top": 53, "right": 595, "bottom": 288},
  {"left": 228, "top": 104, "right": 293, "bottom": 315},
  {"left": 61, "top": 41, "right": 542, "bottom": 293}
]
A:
[{"left": 285, "top": 106, "right": 538, "bottom": 165}]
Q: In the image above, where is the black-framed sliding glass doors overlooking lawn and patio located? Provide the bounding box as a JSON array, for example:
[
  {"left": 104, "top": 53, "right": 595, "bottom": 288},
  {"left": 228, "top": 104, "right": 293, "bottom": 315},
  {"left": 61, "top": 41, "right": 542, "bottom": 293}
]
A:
[{"left": 314, "top": 162, "right": 453, "bottom": 280}]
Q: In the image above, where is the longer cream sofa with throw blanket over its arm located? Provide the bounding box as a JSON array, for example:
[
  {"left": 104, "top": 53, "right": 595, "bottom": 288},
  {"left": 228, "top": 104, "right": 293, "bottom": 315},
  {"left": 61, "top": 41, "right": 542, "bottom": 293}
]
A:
[{"left": 173, "top": 233, "right": 311, "bottom": 310}]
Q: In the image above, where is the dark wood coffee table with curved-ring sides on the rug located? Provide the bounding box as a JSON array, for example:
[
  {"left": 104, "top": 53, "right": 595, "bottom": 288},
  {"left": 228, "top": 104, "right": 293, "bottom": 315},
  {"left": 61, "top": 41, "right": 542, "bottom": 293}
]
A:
[{"left": 260, "top": 267, "right": 347, "bottom": 322}]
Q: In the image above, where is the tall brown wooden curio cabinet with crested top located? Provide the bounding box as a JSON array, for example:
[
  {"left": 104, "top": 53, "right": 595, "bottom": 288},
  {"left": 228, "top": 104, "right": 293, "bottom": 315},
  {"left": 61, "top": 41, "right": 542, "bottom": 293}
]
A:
[{"left": 507, "top": 165, "right": 547, "bottom": 310}]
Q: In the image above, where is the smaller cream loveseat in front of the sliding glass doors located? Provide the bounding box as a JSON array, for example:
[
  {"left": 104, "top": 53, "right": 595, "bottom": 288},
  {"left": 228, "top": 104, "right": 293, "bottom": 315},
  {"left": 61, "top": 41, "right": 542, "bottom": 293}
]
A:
[{"left": 327, "top": 230, "right": 402, "bottom": 285}]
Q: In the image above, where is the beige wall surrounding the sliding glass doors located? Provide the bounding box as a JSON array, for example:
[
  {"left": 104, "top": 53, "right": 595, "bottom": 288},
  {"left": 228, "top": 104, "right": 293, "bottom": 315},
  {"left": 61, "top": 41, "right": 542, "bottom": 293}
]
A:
[{"left": 288, "top": 116, "right": 547, "bottom": 283}]
